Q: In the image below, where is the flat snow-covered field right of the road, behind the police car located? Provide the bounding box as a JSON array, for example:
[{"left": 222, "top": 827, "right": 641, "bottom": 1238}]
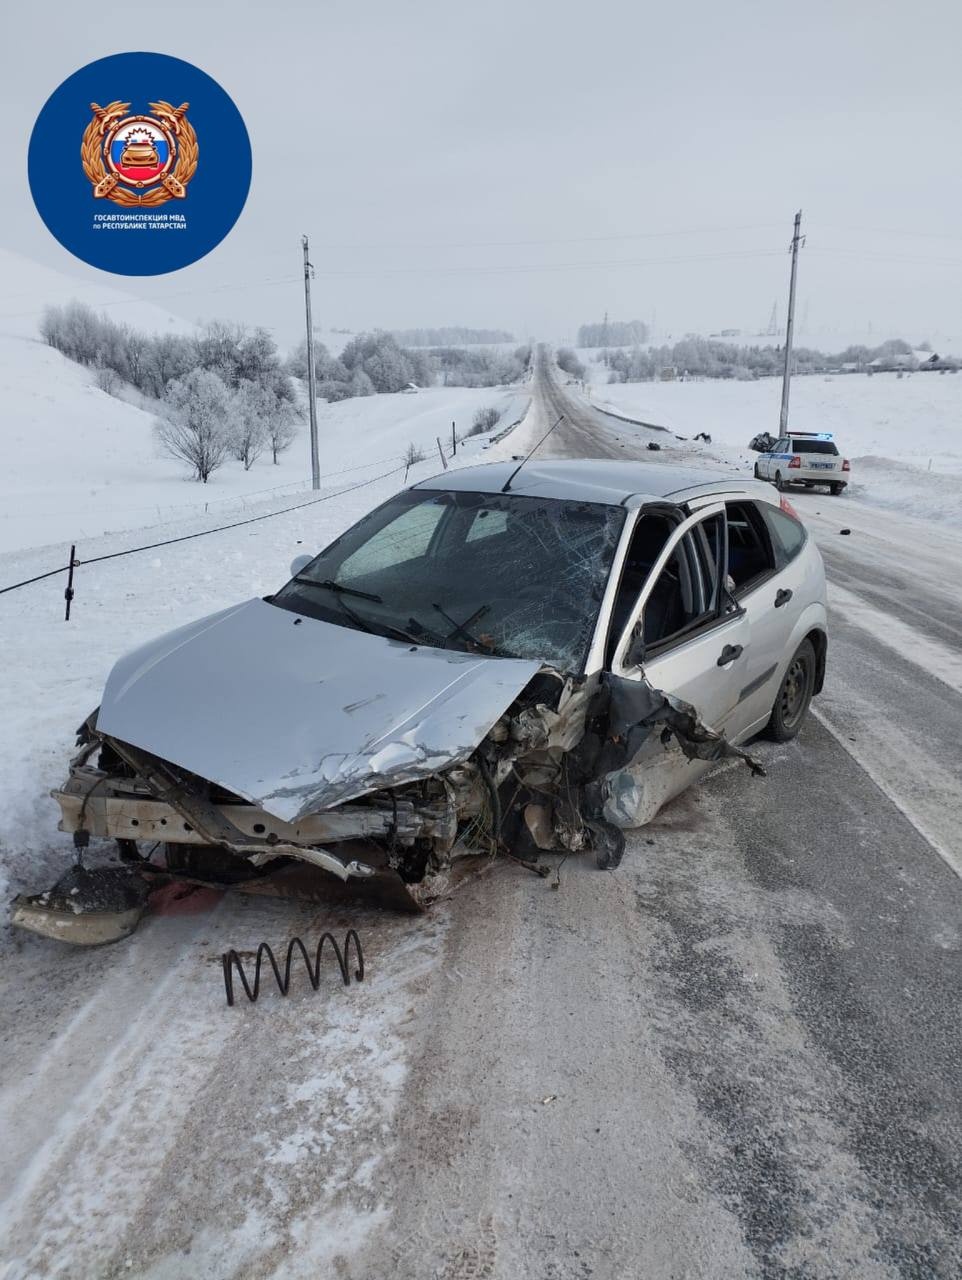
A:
[{"left": 570, "top": 351, "right": 962, "bottom": 525}]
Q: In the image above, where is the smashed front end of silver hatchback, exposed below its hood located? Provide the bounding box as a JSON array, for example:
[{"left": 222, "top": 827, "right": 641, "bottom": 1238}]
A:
[{"left": 13, "top": 667, "right": 761, "bottom": 945}]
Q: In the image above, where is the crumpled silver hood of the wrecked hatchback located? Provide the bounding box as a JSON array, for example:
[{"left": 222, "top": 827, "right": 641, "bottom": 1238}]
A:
[{"left": 97, "top": 599, "right": 542, "bottom": 822}]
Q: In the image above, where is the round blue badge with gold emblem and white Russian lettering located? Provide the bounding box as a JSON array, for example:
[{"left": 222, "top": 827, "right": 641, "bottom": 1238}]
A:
[{"left": 27, "top": 52, "right": 251, "bottom": 275}]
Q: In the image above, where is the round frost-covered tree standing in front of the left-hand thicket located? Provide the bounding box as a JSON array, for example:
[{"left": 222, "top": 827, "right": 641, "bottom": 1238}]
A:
[{"left": 154, "top": 369, "right": 233, "bottom": 484}]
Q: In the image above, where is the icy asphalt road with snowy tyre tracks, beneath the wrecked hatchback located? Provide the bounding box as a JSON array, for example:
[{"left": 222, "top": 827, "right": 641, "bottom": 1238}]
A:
[{"left": 0, "top": 355, "right": 962, "bottom": 1280}]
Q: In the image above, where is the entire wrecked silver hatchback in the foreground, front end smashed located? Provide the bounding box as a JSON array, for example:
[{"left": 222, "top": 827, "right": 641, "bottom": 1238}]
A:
[{"left": 14, "top": 460, "right": 826, "bottom": 943}]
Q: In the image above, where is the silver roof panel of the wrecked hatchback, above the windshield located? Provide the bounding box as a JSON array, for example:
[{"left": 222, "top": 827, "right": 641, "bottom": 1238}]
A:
[{"left": 412, "top": 458, "right": 768, "bottom": 507}]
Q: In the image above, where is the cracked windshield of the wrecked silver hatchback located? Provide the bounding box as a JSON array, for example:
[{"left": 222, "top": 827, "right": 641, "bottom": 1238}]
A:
[{"left": 272, "top": 489, "right": 624, "bottom": 671}]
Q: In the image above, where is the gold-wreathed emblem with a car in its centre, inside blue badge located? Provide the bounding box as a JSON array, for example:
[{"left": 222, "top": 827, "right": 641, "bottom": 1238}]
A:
[{"left": 81, "top": 101, "right": 198, "bottom": 209}]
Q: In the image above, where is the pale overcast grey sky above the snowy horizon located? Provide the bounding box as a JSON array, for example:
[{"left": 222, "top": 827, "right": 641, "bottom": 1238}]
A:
[{"left": 0, "top": 0, "right": 962, "bottom": 346}]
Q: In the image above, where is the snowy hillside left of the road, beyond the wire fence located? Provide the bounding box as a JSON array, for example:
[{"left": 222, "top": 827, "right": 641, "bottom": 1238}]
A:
[{"left": 0, "top": 252, "right": 527, "bottom": 552}]
